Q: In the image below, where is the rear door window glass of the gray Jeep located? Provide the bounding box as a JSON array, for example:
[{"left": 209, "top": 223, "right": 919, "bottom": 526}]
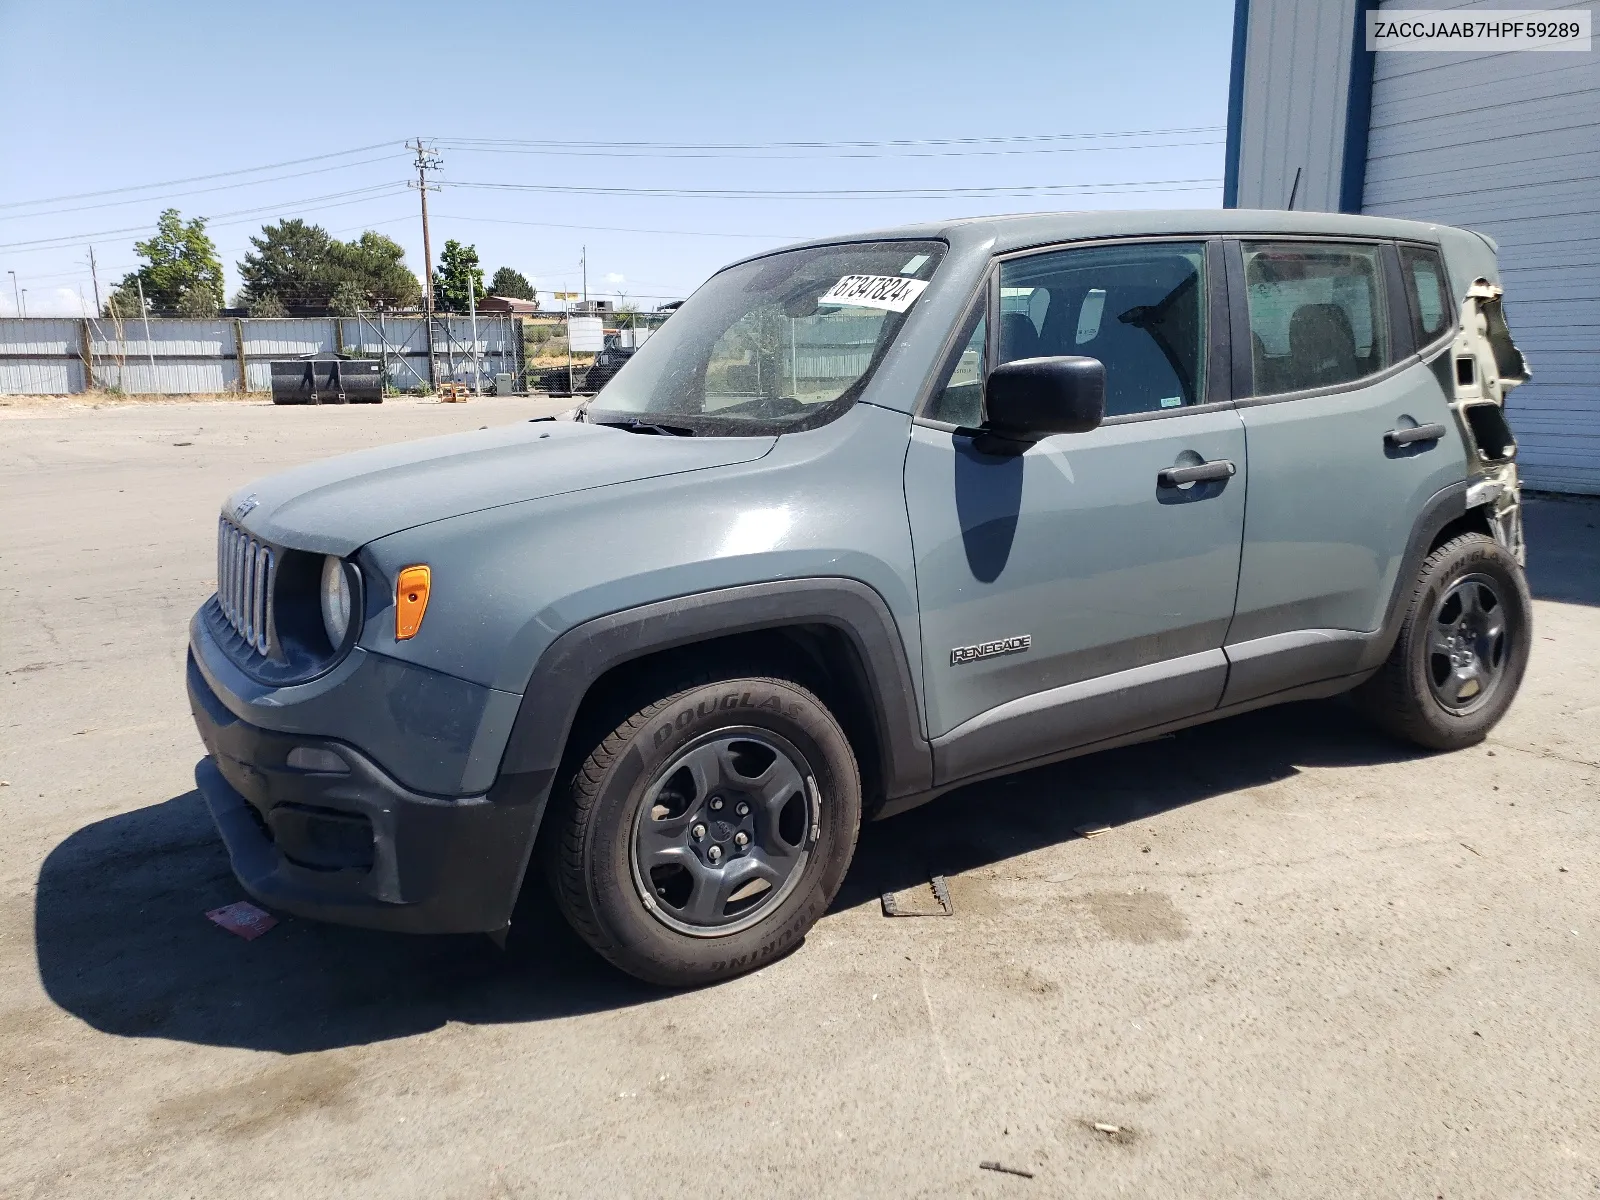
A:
[{"left": 1243, "top": 242, "right": 1389, "bottom": 395}]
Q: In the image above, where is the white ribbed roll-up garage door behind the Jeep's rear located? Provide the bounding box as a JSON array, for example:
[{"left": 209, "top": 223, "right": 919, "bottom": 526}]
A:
[{"left": 1365, "top": 0, "right": 1600, "bottom": 493}]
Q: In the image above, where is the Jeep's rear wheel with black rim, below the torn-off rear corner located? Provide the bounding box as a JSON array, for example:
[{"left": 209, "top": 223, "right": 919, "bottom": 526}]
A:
[{"left": 1355, "top": 533, "right": 1533, "bottom": 750}]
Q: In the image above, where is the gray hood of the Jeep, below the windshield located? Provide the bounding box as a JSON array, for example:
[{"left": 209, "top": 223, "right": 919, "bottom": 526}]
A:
[{"left": 224, "top": 421, "right": 776, "bottom": 555}]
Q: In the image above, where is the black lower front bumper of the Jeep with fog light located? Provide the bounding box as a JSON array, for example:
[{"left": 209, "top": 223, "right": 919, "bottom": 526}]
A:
[{"left": 187, "top": 653, "right": 542, "bottom": 933}]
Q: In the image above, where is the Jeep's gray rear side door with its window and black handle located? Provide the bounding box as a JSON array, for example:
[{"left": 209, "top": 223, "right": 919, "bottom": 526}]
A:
[{"left": 1224, "top": 238, "right": 1466, "bottom": 704}]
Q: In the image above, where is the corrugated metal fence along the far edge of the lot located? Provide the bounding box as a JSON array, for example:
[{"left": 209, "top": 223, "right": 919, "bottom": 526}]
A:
[{"left": 0, "top": 314, "right": 525, "bottom": 395}]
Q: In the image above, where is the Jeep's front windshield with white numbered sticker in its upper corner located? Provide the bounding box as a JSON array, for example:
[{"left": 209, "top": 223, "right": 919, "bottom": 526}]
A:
[{"left": 586, "top": 242, "right": 944, "bottom": 435}]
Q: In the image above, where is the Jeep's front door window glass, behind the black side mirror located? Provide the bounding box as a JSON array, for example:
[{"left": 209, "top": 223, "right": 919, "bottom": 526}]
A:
[{"left": 997, "top": 242, "right": 1206, "bottom": 416}]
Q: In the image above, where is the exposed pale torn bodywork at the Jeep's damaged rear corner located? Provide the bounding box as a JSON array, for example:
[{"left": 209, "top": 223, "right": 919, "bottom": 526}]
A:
[{"left": 1450, "top": 278, "right": 1533, "bottom": 563}]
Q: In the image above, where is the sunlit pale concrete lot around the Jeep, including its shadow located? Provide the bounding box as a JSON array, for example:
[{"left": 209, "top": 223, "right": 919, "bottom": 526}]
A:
[{"left": 0, "top": 400, "right": 1600, "bottom": 1200}]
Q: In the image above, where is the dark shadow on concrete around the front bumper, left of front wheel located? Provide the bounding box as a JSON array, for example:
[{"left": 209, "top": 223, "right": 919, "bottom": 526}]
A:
[{"left": 34, "top": 792, "right": 661, "bottom": 1054}]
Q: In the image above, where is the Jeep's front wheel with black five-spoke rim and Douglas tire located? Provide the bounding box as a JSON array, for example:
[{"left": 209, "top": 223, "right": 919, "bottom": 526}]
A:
[{"left": 549, "top": 677, "right": 861, "bottom": 987}]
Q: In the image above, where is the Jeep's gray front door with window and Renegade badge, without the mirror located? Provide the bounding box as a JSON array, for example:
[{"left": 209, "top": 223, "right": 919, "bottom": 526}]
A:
[{"left": 906, "top": 242, "right": 1246, "bottom": 782}]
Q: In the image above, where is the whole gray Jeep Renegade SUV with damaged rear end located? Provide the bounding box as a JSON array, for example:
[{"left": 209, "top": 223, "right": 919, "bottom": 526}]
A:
[{"left": 187, "top": 211, "right": 1531, "bottom": 984}]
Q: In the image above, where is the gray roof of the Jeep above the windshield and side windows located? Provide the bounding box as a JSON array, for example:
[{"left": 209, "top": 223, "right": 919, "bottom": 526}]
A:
[{"left": 754, "top": 208, "right": 1472, "bottom": 258}]
